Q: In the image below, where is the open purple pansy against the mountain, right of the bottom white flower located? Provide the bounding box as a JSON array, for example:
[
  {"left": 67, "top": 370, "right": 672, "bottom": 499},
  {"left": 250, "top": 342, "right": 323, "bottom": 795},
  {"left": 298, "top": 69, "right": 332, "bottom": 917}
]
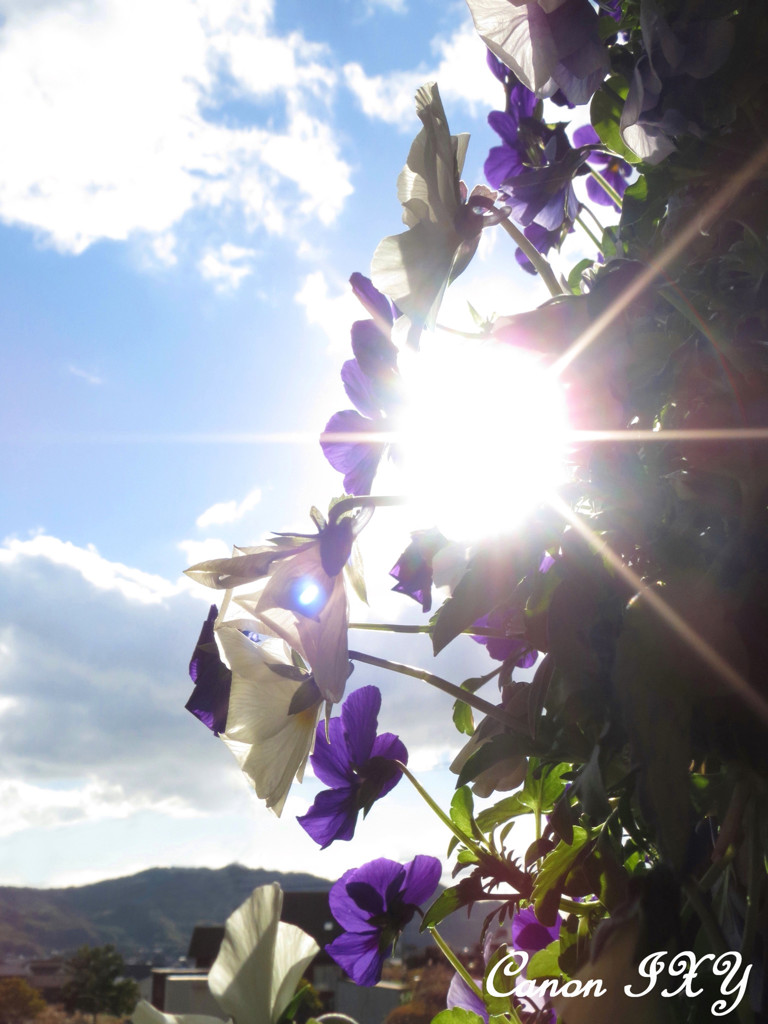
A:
[{"left": 326, "top": 855, "right": 441, "bottom": 985}]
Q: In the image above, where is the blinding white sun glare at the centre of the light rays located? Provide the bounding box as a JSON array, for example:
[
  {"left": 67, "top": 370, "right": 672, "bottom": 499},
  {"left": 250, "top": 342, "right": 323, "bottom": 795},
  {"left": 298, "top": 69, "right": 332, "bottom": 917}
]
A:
[{"left": 397, "top": 335, "right": 567, "bottom": 541}]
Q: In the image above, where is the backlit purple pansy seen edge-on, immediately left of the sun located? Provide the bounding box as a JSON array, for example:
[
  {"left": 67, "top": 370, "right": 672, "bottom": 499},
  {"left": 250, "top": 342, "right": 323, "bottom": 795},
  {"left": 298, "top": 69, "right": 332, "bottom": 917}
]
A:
[{"left": 321, "top": 273, "right": 400, "bottom": 495}]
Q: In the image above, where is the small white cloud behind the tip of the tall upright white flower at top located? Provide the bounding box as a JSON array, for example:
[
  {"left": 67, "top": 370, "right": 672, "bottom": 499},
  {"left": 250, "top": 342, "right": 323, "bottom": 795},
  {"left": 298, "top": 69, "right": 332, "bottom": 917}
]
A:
[{"left": 344, "top": 20, "right": 504, "bottom": 128}]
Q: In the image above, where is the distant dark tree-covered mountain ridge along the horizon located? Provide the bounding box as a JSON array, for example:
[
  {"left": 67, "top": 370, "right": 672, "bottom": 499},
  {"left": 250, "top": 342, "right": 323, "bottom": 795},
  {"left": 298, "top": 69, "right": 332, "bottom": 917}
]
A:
[{"left": 0, "top": 864, "right": 498, "bottom": 964}]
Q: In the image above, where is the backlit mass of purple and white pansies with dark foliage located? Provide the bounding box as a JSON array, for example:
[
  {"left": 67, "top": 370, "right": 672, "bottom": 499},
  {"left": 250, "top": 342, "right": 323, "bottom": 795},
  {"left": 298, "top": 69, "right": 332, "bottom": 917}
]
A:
[{"left": 169, "top": 0, "right": 768, "bottom": 1024}]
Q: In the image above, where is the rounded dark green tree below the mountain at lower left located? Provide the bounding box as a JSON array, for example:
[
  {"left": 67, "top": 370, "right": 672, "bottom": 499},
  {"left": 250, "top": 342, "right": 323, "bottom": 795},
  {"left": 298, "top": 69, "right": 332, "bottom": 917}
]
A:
[{"left": 63, "top": 945, "right": 138, "bottom": 1024}]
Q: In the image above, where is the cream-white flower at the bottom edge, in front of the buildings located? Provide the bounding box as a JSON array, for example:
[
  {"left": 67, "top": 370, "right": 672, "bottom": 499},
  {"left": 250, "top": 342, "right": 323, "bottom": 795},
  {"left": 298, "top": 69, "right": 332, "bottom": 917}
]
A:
[{"left": 132, "top": 883, "right": 319, "bottom": 1024}]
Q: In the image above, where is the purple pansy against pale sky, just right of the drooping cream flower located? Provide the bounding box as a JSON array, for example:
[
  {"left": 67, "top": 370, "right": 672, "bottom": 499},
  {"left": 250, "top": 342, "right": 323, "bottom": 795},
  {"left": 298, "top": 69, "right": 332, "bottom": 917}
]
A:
[{"left": 298, "top": 686, "right": 408, "bottom": 850}]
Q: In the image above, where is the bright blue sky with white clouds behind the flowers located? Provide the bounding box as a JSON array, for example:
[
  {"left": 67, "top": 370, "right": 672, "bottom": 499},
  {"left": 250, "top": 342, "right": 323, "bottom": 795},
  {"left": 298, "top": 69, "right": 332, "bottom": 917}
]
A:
[{"left": 0, "top": 0, "right": 540, "bottom": 886}]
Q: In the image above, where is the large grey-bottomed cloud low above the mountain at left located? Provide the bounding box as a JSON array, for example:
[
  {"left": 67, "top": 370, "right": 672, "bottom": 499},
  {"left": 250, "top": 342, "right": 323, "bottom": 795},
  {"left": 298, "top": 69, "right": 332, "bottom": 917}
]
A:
[{"left": 0, "top": 536, "right": 240, "bottom": 830}]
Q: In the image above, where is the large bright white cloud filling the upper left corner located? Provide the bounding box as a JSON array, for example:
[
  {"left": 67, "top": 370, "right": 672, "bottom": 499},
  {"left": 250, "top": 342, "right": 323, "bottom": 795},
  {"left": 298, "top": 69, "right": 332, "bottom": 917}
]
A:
[{"left": 0, "top": 0, "right": 351, "bottom": 254}]
